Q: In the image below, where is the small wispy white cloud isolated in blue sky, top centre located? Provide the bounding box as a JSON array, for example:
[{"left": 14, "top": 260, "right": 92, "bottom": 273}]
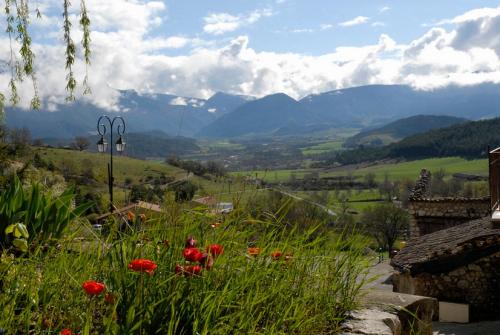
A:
[{"left": 203, "top": 8, "right": 273, "bottom": 35}]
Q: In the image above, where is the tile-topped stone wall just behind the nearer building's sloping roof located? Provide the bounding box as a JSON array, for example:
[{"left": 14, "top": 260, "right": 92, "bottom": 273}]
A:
[{"left": 408, "top": 197, "right": 490, "bottom": 239}]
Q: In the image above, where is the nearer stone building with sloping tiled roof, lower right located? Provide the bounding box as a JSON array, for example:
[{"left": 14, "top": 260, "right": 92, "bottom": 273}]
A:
[{"left": 391, "top": 217, "right": 500, "bottom": 321}]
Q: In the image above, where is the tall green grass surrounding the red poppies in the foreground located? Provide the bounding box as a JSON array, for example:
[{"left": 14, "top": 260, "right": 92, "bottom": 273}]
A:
[{"left": 0, "top": 200, "right": 367, "bottom": 334}]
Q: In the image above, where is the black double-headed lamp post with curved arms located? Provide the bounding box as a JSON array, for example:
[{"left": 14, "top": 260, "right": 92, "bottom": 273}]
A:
[{"left": 97, "top": 115, "right": 125, "bottom": 212}]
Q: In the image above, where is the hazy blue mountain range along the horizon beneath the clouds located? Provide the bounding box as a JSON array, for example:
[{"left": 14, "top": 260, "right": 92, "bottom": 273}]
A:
[{"left": 6, "top": 84, "right": 500, "bottom": 138}]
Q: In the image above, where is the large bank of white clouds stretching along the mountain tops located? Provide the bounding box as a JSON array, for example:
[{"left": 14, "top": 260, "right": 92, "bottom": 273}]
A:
[{"left": 0, "top": 5, "right": 500, "bottom": 110}]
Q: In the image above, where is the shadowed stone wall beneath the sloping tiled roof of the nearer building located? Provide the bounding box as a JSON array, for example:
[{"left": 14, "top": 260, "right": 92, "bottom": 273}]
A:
[{"left": 393, "top": 252, "right": 500, "bottom": 321}]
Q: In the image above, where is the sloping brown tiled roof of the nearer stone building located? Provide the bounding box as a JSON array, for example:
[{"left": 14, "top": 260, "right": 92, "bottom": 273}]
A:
[{"left": 391, "top": 217, "right": 500, "bottom": 275}]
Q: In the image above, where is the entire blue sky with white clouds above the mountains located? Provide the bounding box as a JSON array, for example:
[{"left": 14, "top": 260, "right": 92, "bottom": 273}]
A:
[{"left": 0, "top": 0, "right": 500, "bottom": 107}]
